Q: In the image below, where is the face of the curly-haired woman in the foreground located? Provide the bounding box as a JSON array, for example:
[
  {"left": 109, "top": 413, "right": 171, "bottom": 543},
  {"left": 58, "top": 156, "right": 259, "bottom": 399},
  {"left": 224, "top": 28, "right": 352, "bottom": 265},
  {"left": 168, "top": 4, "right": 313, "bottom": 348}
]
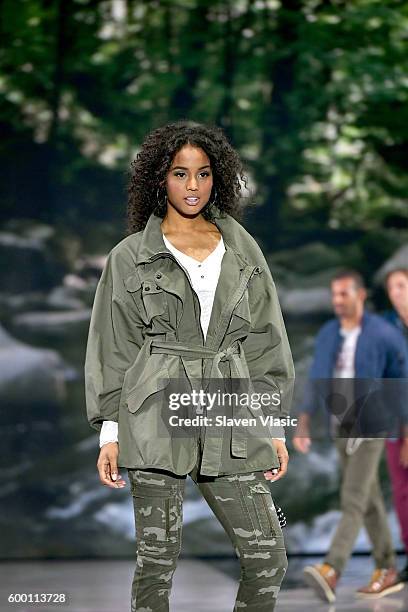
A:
[{"left": 166, "top": 144, "right": 213, "bottom": 215}]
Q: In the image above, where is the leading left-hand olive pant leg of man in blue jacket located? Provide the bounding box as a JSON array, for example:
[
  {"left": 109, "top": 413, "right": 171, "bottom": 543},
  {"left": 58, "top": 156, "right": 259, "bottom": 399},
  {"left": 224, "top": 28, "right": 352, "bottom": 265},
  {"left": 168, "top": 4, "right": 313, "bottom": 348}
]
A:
[{"left": 325, "top": 438, "right": 388, "bottom": 573}]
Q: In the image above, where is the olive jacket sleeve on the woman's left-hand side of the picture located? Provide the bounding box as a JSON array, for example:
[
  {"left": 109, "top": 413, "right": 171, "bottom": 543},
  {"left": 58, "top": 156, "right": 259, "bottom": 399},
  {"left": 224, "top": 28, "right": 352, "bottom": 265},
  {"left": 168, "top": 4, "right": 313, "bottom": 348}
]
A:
[{"left": 84, "top": 251, "right": 143, "bottom": 431}]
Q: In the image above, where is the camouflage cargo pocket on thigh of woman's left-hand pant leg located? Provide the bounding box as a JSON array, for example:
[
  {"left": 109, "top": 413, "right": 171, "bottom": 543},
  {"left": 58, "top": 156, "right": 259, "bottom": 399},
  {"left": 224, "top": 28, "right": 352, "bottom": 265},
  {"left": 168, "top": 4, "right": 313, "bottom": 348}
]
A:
[{"left": 130, "top": 474, "right": 183, "bottom": 554}]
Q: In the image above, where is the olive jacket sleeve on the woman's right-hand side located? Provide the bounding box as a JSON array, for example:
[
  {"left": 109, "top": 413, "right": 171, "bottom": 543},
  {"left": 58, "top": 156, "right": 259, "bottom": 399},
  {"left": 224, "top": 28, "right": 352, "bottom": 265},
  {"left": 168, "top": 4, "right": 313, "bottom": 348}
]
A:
[{"left": 242, "top": 259, "right": 295, "bottom": 417}]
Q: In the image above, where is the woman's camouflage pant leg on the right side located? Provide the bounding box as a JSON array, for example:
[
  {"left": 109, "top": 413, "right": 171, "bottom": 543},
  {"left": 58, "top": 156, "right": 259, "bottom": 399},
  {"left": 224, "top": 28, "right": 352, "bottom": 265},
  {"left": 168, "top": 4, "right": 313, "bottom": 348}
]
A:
[{"left": 190, "top": 471, "right": 288, "bottom": 612}]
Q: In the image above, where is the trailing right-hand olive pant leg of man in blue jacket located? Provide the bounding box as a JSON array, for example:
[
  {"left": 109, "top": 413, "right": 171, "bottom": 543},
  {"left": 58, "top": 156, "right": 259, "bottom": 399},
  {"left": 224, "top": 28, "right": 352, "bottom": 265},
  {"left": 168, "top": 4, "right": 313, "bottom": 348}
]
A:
[{"left": 364, "top": 472, "right": 395, "bottom": 568}]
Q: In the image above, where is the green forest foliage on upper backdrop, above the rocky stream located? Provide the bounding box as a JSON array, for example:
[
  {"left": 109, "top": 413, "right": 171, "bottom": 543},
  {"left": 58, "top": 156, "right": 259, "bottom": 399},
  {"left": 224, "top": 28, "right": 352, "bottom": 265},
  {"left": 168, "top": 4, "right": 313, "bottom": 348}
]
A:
[{"left": 0, "top": 0, "right": 408, "bottom": 248}]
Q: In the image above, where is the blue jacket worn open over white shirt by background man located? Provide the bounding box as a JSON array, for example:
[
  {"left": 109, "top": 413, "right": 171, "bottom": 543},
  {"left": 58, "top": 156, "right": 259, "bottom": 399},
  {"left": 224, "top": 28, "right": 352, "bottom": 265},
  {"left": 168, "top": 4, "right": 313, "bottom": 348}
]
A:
[{"left": 299, "top": 310, "right": 408, "bottom": 430}]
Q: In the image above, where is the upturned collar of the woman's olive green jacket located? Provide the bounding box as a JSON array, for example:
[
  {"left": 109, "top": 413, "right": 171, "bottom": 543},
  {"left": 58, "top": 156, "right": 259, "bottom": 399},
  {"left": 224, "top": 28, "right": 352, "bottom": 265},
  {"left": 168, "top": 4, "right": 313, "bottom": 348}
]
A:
[{"left": 136, "top": 207, "right": 247, "bottom": 264}]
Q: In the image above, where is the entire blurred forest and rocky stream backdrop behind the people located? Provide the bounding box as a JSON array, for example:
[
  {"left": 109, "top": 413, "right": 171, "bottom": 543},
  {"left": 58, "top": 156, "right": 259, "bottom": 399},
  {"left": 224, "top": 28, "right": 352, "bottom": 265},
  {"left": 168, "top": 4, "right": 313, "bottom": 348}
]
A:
[{"left": 0, "top": 0, "right": 408, "bottom": 557}]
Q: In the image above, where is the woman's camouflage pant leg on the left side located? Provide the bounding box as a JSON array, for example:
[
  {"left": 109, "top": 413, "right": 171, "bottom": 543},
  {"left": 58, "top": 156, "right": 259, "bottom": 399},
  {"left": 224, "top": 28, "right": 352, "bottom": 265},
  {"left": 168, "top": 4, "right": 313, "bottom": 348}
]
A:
[{"left": 128, "top": 469, "right": 186, "bottom": 612}]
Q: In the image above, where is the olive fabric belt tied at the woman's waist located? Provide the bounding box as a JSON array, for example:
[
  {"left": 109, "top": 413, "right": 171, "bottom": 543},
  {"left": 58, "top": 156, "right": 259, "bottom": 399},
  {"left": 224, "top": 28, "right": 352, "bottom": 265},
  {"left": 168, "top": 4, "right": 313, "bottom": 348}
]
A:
[{"left": 150, "top": 339, "right": 248, "bottom": 457}]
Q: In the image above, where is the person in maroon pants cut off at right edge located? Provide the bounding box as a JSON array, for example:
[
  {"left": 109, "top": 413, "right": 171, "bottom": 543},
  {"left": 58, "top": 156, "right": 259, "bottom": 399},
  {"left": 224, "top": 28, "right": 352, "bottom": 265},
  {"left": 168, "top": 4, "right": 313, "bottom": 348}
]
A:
[{"left": 384, "top": 267, "right": 408, "bottom": 582}]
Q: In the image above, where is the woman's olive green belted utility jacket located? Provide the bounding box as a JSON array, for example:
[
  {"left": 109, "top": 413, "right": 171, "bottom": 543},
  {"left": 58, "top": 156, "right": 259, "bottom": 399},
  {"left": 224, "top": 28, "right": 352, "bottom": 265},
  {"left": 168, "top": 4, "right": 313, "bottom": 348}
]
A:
[{"left": 84, "top": 209, "right": 294, "bottom": 476}]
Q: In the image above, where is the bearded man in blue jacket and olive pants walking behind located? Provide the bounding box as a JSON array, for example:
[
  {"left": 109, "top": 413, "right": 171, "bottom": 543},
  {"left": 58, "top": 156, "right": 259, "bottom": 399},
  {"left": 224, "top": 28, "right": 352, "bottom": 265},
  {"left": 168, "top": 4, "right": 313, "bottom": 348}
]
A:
[{"left": 293, "top": 270, "right": 408, "bottom": 602}]
